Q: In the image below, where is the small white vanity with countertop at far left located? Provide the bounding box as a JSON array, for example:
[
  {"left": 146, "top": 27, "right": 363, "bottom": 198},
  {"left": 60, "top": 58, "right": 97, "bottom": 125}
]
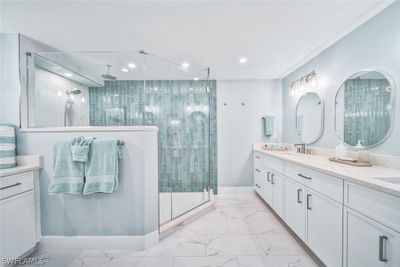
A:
[{"left": 0, "top": 156, "right": 41, "bottom": 266}]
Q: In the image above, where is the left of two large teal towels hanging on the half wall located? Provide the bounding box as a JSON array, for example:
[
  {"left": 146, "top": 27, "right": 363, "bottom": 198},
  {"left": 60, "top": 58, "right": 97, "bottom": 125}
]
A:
[{"left": 48, "top": 141, "right": 85, "bottom": 195}]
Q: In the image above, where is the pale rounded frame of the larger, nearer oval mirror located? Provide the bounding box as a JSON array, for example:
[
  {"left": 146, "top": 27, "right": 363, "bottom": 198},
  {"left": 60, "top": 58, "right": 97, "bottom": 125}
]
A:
[{"left": 333, "top": 69, "right": 396, "bottom": 149}]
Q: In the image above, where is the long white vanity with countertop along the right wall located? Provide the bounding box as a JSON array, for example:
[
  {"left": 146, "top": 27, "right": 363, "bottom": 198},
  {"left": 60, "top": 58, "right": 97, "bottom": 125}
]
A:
[{"left": 253, "top": 149, "right": 400, "bottom": 267}]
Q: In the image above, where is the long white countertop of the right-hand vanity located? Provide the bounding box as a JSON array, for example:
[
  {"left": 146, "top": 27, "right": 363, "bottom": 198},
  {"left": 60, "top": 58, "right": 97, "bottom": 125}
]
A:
[{"left": 253, "top": 148, "right": 400, "bottom": 197}]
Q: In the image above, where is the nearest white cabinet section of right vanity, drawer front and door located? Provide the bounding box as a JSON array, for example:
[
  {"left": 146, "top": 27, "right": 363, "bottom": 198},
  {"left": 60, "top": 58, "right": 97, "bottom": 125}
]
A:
[{"left": 343, "top": 182, "right": 400, "bottom": 267}]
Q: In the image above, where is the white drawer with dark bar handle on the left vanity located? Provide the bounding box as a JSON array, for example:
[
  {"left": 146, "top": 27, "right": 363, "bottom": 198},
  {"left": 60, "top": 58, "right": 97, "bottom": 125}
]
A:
[{"left": 0, "top": 171, "right": 33, "bottom": 200}]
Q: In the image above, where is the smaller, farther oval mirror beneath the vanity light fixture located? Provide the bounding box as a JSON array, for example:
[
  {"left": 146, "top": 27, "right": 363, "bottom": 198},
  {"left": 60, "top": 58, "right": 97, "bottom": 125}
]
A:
[{"left": 296, "top": 92, "right": 324, "bottom": 145}]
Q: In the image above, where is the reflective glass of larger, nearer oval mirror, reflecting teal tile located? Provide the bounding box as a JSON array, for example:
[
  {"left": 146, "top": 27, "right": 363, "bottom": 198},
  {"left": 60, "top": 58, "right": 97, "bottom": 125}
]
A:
[{"left": 335, "top": 71, "right": 394, "bottom": 148}]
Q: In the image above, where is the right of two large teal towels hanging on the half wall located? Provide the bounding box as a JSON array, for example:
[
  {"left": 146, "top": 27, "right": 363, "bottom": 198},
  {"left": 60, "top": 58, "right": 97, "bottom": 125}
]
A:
[{"left": 83, "top": 139, "right": 121, "bottom": 195}]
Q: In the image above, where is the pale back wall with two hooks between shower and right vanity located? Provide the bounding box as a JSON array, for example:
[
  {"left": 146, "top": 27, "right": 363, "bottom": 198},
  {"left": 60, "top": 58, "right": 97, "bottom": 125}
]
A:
[{"left": 217, "top": 80, "right": 282, "bottom": 186}]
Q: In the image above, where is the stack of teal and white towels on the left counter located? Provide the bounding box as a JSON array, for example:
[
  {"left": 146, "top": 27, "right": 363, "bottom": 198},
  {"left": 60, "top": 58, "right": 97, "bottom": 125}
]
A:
[{"left": 0, "top": 125, "right": 17, "bottom": 169}]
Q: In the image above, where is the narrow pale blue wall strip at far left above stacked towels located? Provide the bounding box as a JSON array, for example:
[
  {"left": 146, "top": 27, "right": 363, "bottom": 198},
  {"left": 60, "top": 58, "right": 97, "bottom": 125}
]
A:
[{"left": 0, "top": 33, "right": 20, "bottom": 126}]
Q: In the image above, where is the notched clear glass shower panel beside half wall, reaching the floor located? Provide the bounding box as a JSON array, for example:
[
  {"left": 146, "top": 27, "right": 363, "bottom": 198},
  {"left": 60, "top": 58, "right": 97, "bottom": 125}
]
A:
[{"left": 144, "top": 55, "right": 210, "bottom": 224}]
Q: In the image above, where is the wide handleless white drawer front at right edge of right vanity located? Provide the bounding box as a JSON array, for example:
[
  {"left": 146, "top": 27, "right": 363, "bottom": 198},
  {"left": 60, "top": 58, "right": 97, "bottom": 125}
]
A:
[{"left": 344, "top": 182, "right": 400, "bottom": 232}]
